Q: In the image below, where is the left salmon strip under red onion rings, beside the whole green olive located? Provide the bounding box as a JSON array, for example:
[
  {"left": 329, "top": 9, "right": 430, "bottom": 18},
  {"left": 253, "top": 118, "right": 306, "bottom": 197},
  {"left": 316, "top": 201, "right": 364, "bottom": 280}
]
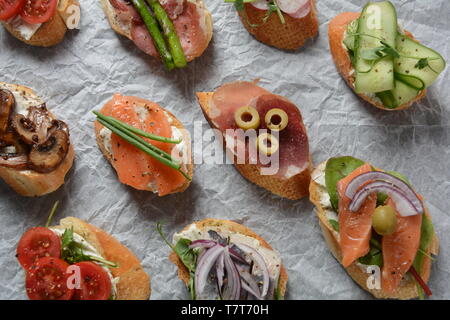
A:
[{"left": 337, "top": 163, "right": 377, "bottom": 267}]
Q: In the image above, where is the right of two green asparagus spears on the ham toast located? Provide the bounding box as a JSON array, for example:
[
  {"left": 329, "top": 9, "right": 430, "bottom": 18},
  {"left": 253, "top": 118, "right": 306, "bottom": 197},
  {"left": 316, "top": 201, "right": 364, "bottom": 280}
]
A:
[{"left": 147, "top": 0, "right": 187, "bottom": 68}]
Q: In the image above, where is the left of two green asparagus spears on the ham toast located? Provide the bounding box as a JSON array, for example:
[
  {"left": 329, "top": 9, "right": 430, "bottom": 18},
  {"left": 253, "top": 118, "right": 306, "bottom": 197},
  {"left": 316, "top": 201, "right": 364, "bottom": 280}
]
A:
[{"left": 131, "top": 0, "right": 175, "bottom": 70}]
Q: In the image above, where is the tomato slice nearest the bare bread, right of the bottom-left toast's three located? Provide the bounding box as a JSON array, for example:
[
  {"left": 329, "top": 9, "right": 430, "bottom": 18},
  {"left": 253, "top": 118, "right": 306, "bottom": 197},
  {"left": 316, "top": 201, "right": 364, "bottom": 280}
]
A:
[{"left": 73, "top": 261, "right": 112, "bottom": 300}]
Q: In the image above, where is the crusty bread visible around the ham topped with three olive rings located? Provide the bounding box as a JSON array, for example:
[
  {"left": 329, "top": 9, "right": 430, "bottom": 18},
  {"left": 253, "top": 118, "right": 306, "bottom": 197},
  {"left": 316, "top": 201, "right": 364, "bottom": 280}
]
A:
[{"left": 197, "top": 92, "right": 312, "bottom": 200}]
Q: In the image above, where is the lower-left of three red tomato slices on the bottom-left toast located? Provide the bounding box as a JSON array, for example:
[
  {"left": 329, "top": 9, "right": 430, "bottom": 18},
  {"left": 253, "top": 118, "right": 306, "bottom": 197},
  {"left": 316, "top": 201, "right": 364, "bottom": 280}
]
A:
[{"left": 25, "top": 257, "right": 73, "bottom": 300}]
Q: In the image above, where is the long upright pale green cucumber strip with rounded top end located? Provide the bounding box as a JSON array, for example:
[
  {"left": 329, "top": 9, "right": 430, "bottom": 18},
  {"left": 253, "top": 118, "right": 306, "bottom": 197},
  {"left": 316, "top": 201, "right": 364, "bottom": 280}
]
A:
[{"left": 355, "top": 1, "right": 397, "bottom": 93}]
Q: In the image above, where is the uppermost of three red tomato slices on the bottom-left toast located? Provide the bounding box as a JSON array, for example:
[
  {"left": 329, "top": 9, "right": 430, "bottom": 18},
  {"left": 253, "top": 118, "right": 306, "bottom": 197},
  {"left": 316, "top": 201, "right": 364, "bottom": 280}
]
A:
[{"left": 16, "top": 226, "right": 61, "bottom": 269}]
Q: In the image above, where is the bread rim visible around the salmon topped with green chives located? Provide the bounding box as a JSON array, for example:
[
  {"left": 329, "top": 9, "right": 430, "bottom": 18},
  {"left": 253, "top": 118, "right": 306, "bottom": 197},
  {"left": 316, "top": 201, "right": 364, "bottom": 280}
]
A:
[{"left": 94, "top": 95, "right": 194, "bottom": 193}]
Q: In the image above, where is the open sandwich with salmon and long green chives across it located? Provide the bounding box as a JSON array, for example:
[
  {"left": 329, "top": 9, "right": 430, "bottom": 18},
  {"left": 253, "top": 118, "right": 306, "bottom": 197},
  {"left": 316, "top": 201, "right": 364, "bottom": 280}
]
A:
[{"left": 94, "top": 94, "right": 194, "bottom": 196}]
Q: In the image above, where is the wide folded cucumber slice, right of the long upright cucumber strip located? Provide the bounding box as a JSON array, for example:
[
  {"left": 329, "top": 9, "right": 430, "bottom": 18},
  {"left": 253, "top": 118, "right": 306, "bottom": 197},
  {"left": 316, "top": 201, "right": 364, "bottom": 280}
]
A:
[{"left": 394, "top": 34, "right": 445, "bottom": 87}]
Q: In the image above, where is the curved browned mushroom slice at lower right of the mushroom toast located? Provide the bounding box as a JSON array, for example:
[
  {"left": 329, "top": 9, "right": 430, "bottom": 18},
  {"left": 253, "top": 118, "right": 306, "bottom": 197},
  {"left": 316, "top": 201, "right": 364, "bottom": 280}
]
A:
[{"left": 28, "top": 129, "right": 70, "bottom": 173}]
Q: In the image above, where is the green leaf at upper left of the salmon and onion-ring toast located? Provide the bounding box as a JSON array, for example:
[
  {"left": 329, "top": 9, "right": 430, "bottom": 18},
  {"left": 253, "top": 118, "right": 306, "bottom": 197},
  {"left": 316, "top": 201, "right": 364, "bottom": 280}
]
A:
[{"left": 325, "top": 156, "right": 364, "bottom": 212}]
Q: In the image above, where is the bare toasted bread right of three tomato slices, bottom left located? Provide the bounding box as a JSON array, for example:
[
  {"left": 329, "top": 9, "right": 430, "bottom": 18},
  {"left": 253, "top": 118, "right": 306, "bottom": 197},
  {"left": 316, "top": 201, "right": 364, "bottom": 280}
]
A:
[{"left": 52, "top": 217, "right": 151, "bottom": 300}]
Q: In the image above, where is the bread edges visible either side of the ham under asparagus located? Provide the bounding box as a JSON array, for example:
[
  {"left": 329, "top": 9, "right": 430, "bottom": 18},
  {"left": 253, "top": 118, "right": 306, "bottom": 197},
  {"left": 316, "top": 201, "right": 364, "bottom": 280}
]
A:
[{"left": 100, "top": 0, "right": 213, "bottom": 62}]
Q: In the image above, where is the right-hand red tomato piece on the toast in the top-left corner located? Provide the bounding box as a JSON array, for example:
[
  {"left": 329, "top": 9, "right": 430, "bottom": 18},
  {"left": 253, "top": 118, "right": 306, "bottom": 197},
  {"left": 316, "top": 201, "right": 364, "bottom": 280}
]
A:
[{"left": 20, "top": 0, "right": 58, "bottom": 24}]
